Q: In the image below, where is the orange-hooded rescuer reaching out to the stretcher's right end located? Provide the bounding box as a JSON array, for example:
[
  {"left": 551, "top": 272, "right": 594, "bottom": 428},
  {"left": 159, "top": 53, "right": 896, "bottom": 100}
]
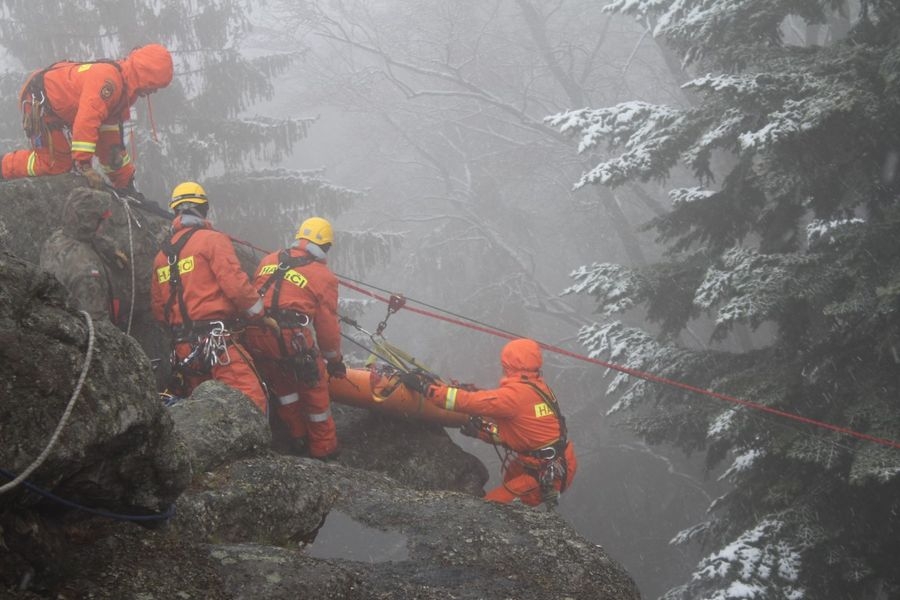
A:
[{"left": 404, "top": 339, "right": 578, "bottom": 506}]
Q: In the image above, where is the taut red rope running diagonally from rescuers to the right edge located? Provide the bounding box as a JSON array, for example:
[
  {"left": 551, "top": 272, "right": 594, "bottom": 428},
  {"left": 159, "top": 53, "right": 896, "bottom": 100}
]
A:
[{"left": 232, "top": 238, "right": 900, "bottom": 450}]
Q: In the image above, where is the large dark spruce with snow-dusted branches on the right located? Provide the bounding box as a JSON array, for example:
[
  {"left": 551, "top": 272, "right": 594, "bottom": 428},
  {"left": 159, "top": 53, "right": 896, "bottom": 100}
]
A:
[{"left": 549, "top": 0, "right": 900, "bottom": 600}]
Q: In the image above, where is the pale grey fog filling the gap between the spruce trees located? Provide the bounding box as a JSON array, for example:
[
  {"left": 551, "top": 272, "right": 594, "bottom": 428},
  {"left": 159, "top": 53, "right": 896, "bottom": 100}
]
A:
[{"left": 241, "top": 2, "right": 718, "bottom": 598}]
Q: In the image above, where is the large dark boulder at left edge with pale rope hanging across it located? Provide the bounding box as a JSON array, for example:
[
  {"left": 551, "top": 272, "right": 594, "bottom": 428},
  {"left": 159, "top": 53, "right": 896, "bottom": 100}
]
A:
[{"left": 0, "top": 253, "right": 190, "bottom": 511}]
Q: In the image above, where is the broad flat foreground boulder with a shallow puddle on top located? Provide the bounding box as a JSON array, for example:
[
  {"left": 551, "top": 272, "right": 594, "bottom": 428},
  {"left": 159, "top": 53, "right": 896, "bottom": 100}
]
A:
[{"left": 0, "top": 450, "right": 640, "bottom": 600}]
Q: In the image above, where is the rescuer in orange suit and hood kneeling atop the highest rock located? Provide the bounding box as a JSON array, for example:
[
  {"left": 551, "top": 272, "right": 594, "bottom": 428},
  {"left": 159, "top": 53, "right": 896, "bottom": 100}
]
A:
[{"left": 0, "top": 44, "right": 173, "bottom": 192}]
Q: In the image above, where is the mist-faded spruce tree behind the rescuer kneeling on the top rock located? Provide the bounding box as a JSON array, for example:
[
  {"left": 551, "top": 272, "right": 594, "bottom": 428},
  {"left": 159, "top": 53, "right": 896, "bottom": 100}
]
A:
[{"left": 0, "top": 0, "right": 374, "bottom": 253}]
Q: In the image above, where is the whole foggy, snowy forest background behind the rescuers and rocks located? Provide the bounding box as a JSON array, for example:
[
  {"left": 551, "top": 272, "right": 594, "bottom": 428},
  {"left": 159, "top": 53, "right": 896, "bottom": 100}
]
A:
[{"left": 0, "top": 0, "right": 900, "bottom": 600}]
